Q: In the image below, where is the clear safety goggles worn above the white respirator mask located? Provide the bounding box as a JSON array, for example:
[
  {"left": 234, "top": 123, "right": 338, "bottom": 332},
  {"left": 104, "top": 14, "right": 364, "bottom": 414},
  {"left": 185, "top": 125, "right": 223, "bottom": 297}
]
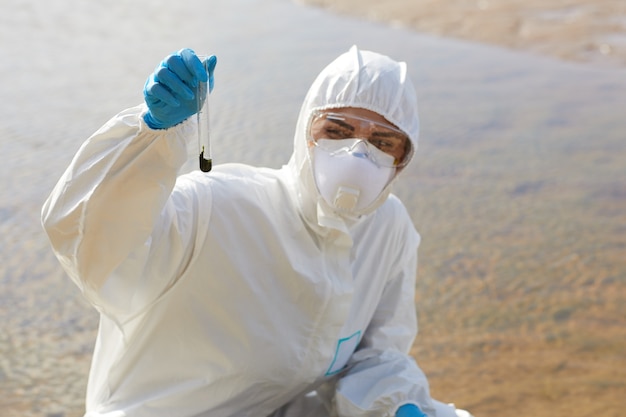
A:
[{"left": 308, "top": 111, "right": 413, "bottom": 168}]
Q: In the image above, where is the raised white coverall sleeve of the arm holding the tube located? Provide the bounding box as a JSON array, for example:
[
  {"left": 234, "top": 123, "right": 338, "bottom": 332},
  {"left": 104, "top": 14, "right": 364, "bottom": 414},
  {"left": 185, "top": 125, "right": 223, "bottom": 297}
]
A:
[{"left": 42, "top": 106, "right": 207, "bottom": 321}]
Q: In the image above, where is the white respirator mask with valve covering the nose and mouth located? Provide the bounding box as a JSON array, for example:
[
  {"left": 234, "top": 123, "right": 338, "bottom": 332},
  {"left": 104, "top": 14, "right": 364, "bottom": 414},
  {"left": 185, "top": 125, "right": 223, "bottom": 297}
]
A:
[{"left": 312, "top": 139, "right": 396, "bottom": 212}]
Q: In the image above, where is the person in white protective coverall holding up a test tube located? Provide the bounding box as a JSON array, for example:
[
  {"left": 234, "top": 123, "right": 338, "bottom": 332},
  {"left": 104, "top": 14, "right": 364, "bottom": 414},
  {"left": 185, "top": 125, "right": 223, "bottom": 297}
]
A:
[{"left": 42, "top": 46, "right": 469, "bottom": 417}]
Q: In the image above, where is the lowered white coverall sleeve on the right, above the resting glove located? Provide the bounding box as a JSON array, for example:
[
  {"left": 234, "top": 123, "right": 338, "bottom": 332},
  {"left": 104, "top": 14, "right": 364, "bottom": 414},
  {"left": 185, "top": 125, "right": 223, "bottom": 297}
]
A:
[{"left": 335, "top": 228, "right": 434, "bottom": 417}]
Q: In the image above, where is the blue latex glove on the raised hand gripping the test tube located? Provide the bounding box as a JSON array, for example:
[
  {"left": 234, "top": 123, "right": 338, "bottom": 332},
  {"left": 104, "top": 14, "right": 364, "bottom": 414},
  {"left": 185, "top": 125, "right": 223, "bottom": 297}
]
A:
[{"left": 143, "top": 49, "right": 217, "bottom": 129}]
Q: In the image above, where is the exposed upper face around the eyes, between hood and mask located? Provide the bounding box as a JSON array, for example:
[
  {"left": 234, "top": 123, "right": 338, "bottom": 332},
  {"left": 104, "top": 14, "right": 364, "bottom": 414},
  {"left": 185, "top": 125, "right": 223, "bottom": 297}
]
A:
[{"left": 310, "top": 107, "right": 411, "bottom": 167}]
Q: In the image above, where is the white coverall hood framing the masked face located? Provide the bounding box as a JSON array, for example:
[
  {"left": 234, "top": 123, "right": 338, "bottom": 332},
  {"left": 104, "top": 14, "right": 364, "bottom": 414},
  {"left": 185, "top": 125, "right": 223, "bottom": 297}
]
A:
[{"left": 288, "top": 46, "right": 419, "bottom": 234}]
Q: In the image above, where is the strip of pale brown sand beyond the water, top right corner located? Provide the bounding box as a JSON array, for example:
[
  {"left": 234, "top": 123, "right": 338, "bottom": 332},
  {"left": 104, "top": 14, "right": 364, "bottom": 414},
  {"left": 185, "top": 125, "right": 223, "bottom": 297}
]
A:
[{"left": 300, "top": 0, "right": 626, "bottom": 68}]
